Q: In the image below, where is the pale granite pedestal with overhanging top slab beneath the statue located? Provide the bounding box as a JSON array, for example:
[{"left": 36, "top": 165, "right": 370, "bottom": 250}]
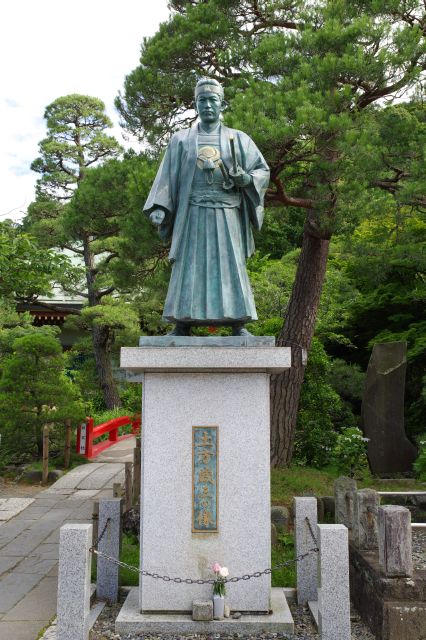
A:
[{"left": 121, "top": 338, "right": 291, "bottom": 614}]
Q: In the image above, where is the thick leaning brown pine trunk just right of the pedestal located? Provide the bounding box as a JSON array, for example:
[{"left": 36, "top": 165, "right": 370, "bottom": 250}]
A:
[{"left": 270, "top": 224, "right": 330, "bottom": 467}]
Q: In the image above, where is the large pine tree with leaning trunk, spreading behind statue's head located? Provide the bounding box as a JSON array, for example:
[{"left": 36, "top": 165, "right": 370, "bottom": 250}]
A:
[{"left": 116, "top": 0, "right": 426, "bottom": 465}]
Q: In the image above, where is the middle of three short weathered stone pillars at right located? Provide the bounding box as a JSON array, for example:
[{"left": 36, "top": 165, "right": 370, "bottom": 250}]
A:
[{"left": 353, "top": 489, "right": 380, "bottom": 551}]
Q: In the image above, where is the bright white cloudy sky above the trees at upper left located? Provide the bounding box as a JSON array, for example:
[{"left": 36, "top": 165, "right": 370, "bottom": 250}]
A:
[{"left": 0, "top": 0, "right": 169, "bottom": 220}]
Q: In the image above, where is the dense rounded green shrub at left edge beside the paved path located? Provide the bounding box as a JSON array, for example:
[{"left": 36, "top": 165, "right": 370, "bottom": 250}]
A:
[{"left": 0, "top": 332, "right": 84, "bottom": 460}]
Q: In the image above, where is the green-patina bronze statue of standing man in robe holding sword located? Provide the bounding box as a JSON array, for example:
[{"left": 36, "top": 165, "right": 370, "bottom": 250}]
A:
[{"left": 144, "top": 78, "right": 269, "bottom": 336}]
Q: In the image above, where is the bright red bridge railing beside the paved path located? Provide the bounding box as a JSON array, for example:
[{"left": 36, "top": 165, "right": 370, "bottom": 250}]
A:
[{"left": 77, "top": 416, "right": 141, "bottom": 458}]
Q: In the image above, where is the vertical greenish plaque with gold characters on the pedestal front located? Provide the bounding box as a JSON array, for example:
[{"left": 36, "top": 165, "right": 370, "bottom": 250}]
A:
[{"left": 192, "top": 427, "right": 219, "bottom": 533}]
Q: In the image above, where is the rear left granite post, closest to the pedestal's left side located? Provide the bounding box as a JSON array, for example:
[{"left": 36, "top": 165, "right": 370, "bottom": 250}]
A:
[{"left": 96, "top": 498, "right": 121, "bottom": 602}]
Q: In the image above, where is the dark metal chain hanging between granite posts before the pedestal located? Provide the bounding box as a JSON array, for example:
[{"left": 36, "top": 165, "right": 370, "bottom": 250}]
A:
[{"left": 90, "top": 518, "right": 318, "bottom": 584}]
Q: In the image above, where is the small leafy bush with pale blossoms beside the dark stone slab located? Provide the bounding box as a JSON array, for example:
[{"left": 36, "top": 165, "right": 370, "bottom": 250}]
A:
[{"left": 332, "top": 427, "right": 368, "bottom": 478}]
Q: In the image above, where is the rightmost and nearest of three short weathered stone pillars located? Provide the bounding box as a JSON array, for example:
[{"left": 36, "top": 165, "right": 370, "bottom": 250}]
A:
[{"left": 379, "top": 505, "right": 413, "bottom": 578}]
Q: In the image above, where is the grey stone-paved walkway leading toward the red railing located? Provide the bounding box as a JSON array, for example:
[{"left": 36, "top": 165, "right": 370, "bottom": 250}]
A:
[{"left": 0, "top": 439, "right": 134, "bottom": 640}]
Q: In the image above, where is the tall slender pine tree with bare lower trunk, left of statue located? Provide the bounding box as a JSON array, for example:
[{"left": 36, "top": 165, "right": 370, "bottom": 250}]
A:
[{"left": 26, "top": 94, "right": 145, "bottom": 407}]
